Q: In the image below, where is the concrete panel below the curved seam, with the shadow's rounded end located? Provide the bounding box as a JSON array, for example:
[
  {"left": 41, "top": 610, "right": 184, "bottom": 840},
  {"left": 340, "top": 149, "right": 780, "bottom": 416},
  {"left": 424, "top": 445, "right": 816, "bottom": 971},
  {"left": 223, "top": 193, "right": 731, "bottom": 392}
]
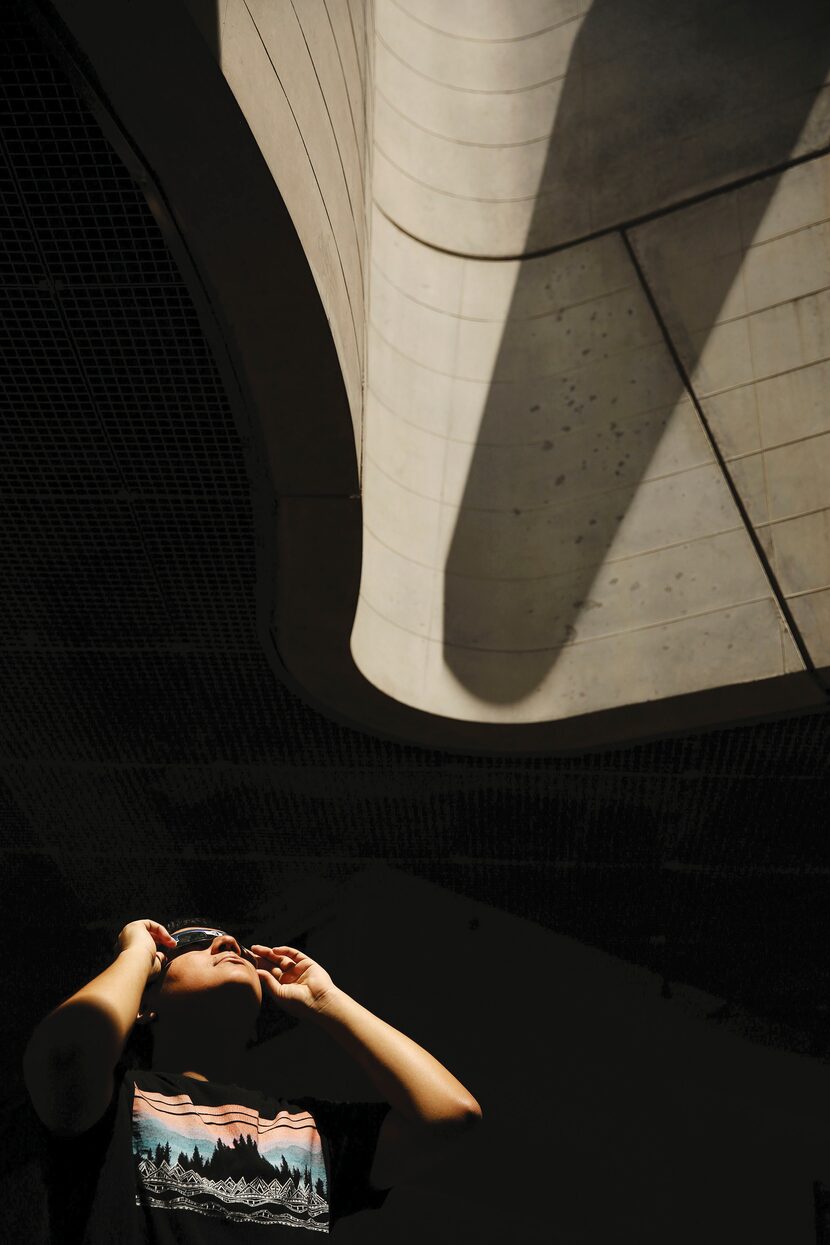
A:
[{"left": 353, "top": 211, "right": 799, "bottom": 721}]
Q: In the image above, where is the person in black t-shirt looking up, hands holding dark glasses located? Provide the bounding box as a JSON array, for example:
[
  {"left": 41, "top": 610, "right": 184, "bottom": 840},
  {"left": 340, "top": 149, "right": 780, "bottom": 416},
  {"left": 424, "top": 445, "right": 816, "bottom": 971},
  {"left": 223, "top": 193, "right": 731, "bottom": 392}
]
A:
[{"left": 24, "top": 920, "right": 482, "bottom": 1245}]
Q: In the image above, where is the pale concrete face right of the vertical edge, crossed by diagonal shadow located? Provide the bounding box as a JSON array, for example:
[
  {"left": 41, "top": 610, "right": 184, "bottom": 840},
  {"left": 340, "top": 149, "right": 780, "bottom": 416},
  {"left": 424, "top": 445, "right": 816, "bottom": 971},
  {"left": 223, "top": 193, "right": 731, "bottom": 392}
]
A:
[{"left": 352, "top": 0, "right": 830, "bottom": 723}]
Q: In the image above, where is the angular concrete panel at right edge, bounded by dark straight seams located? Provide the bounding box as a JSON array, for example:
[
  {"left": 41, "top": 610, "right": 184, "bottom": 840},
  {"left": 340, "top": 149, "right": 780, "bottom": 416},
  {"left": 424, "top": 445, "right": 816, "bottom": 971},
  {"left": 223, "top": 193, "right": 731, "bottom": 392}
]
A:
[{"left": 633, "top": 157, "right": 830, "bottom": 666}]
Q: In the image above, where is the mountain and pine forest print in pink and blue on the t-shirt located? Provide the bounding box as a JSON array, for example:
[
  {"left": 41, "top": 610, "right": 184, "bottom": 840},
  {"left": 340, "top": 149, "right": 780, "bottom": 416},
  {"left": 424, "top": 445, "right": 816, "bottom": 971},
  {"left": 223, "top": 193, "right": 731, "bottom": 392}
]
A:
[{"left": 132, "top": 1086, "right": 329, "bottom": 1233}]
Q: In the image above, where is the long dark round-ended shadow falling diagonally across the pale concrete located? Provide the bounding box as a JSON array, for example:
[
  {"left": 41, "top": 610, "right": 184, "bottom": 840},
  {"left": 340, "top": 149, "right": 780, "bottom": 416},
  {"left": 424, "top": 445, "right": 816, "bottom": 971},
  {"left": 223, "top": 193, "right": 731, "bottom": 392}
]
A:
[{"left": 444, "top": 0, "right": 830, "bottom": 703}]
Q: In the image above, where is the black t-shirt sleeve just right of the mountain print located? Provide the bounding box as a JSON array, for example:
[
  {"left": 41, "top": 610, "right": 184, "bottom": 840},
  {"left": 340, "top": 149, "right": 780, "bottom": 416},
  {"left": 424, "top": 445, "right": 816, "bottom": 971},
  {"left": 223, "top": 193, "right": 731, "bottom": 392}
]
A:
[{"left": 300, "top": 1098, "right": 391, "bottom": 1226}]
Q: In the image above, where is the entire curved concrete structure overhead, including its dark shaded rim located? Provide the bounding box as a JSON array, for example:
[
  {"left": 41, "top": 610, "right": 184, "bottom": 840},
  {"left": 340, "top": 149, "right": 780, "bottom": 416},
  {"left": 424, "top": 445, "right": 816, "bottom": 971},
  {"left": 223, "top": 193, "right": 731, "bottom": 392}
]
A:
[{"left": 48, "top": 0, "right": 830, "bottom": 751}]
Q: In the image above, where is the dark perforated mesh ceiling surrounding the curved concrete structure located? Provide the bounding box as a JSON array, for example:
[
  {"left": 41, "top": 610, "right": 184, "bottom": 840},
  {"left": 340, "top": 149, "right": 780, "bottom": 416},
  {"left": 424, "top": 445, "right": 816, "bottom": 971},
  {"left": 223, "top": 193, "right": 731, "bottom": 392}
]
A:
[{"left": 0, "top": 5, "right": 830, "bottom": 1075}]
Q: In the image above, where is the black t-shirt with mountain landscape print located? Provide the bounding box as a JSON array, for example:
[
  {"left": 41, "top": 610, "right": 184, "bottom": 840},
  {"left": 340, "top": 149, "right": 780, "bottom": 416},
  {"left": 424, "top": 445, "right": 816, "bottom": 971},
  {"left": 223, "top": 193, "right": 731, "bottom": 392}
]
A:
[{"left": 37, "top": 1064, "right": 389, "bottom": 1245}]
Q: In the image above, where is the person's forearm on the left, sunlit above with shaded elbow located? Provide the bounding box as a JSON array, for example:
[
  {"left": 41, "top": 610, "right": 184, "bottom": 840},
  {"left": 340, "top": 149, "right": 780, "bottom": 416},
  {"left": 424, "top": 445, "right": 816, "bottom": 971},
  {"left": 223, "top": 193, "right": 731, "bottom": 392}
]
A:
[{"left": 29, "top": 946, "right": 152, "bottom": 1068}]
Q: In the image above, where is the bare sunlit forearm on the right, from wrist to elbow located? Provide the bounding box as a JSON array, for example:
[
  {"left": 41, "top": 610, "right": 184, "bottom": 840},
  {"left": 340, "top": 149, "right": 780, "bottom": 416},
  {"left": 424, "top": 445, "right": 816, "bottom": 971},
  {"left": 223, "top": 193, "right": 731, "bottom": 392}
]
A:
[{"left": 315, "top": 989, "right": 480, "bottom": 1124}]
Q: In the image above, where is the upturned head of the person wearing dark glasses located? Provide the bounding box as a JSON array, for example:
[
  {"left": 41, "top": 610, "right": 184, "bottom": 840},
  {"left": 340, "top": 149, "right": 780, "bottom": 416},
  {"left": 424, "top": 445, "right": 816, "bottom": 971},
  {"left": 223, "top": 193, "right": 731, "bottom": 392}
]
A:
[{"left": 136, "top": 919, "right": 263, "bottom": 1079}]
